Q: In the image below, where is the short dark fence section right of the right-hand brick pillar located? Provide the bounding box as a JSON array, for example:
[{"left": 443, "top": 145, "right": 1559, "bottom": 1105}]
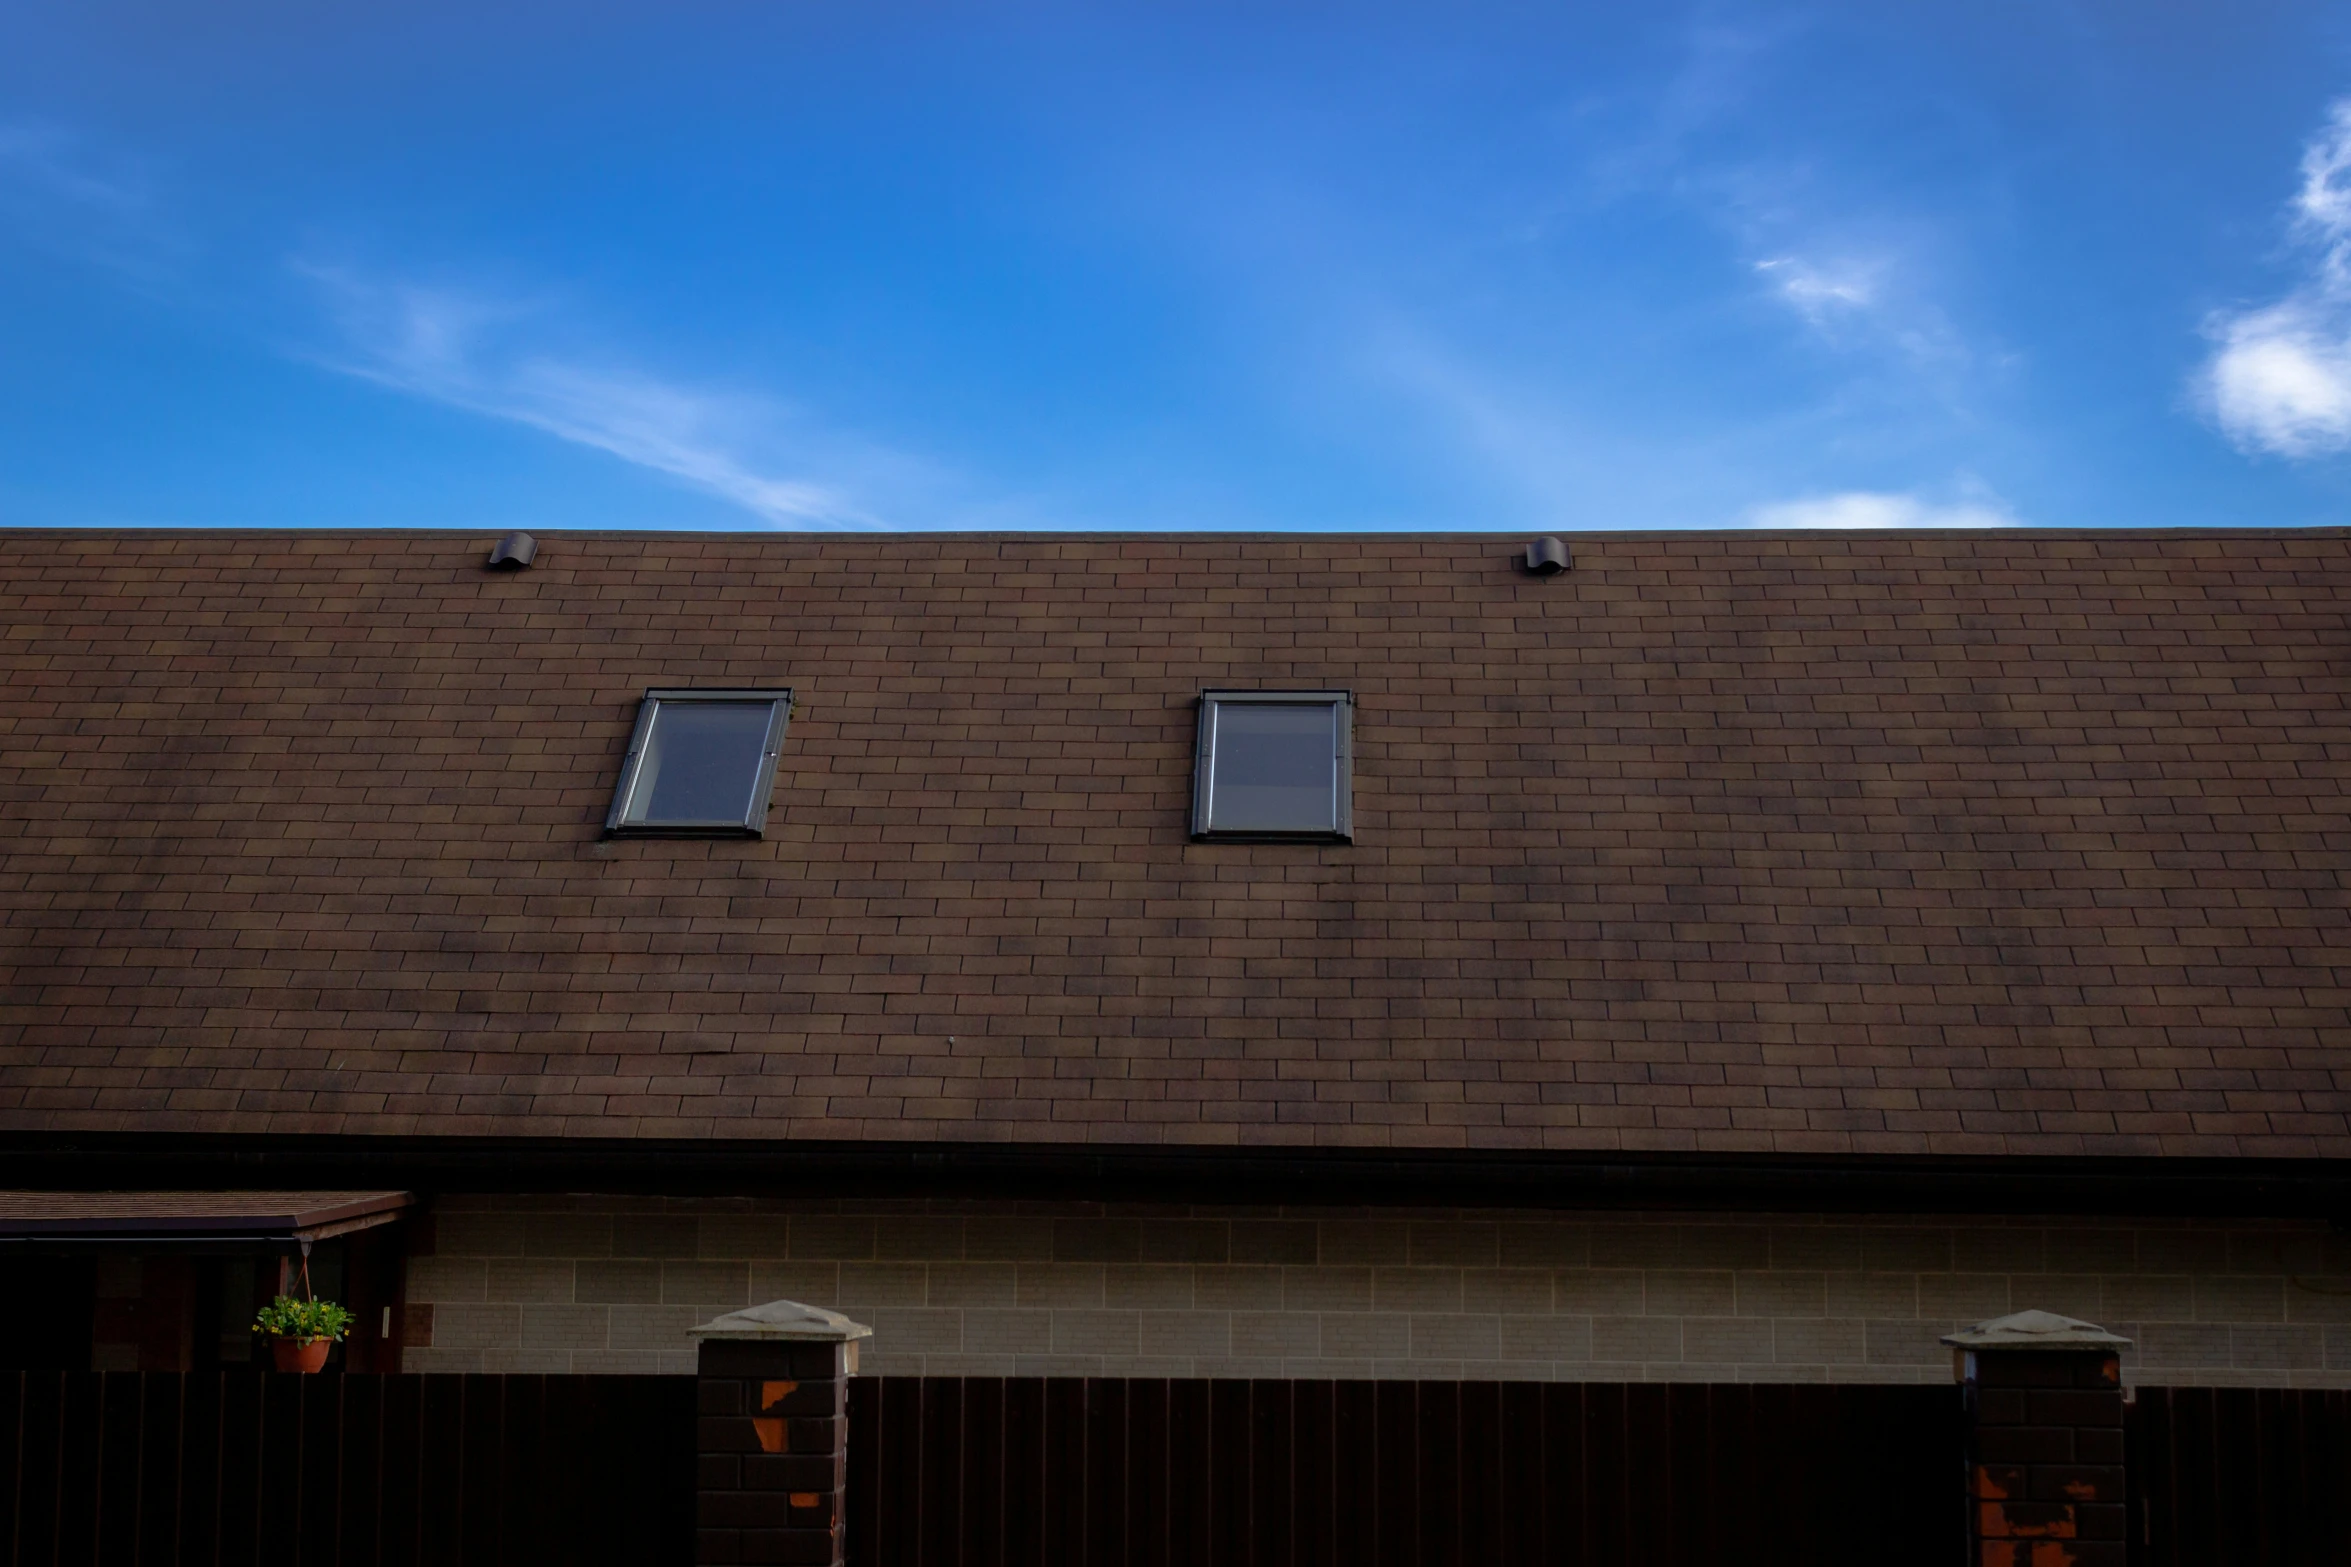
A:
[{"left": 2123, "top": 1388, "right": 2351, "bottom": 1567}]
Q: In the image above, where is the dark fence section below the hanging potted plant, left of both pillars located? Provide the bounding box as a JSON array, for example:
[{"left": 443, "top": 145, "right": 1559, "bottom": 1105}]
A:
[{"left": 0, "top": 1372, "right": 694, "bottom": 1567}]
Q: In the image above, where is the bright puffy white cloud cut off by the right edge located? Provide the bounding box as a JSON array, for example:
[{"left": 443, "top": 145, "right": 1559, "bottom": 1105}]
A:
[{"left": 2196, "top": 99, "right": 2351, "bottom": 458}]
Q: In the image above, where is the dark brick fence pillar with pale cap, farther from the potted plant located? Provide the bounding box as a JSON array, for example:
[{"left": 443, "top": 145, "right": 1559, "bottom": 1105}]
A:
[{"left": 1944, "top": 1311, "right": 2130, "bottom": 1567}]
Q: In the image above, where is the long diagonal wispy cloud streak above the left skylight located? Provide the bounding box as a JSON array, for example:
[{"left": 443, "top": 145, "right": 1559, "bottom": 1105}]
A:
[{"left": 296, "top": 263, "right": 889, "bottom": 529}]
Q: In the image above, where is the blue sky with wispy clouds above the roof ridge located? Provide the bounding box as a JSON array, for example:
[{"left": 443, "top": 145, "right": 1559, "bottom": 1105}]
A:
[{"left": 0, "top": 0, "right": 2351, "bottom": 531}]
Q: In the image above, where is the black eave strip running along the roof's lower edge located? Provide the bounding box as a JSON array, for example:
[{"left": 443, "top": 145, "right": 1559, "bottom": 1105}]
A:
[{"left": 0, "top": 1132, "right": 2351, "bottom": 1229}]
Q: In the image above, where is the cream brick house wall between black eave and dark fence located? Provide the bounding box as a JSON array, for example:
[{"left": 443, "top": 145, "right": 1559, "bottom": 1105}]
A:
[{"left": 404, "top": 1196, "right": 2351, "bottom": 1386}]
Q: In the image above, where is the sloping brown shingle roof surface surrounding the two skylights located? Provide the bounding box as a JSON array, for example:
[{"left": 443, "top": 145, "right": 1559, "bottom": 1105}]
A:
[{"left": 0, "top": 531, "right": 2351, "bottom": 1156}]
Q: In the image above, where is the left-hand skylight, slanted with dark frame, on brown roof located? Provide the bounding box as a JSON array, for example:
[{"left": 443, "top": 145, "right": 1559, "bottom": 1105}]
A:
[{"left": 604, "top": 691, "right": 792, "bottom": 839}]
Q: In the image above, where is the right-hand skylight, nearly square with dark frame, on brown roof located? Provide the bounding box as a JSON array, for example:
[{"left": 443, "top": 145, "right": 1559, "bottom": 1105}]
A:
[{"left": 1192, "top": 691, "right": 1354, "bottom": 843}]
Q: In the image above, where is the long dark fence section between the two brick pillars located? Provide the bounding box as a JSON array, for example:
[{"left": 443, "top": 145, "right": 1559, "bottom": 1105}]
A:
[{"left": 849, "top": 1377, "right": 1965, "bottom": 1567}]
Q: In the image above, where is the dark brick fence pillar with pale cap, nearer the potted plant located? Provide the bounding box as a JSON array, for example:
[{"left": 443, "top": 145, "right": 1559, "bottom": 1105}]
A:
[{"left": 694, "top": 1302, "right": 872, "bottom": 1567}]
